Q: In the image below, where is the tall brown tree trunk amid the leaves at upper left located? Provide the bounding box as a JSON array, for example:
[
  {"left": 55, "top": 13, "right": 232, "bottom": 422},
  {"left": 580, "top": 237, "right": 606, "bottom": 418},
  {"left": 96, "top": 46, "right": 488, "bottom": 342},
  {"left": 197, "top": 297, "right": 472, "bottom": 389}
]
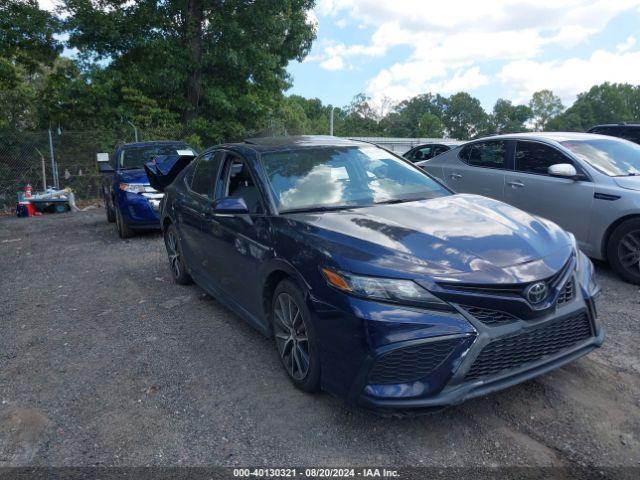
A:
[{"left": 183, "top": 0, "right": 204, "bottom": 122}]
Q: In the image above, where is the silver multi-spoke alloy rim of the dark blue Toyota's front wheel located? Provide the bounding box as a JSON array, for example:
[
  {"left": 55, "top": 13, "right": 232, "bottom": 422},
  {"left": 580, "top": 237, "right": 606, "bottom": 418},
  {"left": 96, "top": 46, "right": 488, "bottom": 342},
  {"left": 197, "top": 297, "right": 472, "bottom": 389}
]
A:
[{"left": 273, "top": 292, "right": 309, "bottom": 380}]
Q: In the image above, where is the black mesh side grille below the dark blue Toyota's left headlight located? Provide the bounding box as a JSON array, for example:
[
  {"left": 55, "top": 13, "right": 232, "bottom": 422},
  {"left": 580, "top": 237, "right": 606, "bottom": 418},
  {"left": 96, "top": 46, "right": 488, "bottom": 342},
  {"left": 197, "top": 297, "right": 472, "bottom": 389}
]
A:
[{"left": 369, "top": 338, "right": 460, "bottom": 385}]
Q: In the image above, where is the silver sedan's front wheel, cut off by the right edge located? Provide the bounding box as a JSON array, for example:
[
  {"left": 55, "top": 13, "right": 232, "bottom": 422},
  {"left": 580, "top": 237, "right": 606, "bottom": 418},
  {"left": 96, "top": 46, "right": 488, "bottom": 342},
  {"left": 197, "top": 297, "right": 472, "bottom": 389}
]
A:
[{"left": 607, "top": 218, "right": 640, "bottom": 285}]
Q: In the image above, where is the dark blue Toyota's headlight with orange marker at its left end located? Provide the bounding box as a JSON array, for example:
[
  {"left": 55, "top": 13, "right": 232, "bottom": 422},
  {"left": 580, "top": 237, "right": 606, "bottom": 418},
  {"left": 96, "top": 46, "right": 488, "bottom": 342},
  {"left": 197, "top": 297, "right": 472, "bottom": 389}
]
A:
[{"left": 321, "top": 268, "right": 453, "bottom": 310}]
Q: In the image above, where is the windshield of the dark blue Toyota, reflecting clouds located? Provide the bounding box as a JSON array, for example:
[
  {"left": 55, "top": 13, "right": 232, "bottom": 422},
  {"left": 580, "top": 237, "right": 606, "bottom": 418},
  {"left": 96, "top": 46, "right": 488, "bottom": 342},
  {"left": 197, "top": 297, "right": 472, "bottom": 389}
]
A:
[{"left": 262, "top": 146, "right": 449, "bottom": 213}]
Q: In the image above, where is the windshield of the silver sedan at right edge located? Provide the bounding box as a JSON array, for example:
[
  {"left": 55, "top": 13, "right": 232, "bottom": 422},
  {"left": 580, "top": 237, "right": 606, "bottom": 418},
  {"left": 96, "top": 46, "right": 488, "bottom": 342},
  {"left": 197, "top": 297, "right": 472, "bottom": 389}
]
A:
[{"left": 561, "top": 139, "right": 640, "bottom": 177}]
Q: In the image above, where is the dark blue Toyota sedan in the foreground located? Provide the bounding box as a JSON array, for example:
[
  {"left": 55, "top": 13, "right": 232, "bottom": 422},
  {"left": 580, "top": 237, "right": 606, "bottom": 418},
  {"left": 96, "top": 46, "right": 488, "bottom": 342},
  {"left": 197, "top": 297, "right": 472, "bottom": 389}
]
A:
[{"left": 152, "top": 137, "right": 604, "bottom": 411}]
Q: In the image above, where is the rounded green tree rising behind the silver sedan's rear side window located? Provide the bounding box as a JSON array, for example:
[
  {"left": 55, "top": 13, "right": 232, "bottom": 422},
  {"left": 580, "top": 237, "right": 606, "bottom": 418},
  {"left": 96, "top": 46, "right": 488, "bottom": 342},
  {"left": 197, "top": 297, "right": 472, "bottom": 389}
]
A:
[{"left": 442, "top": 92, "right": 490, "bottom": 140}]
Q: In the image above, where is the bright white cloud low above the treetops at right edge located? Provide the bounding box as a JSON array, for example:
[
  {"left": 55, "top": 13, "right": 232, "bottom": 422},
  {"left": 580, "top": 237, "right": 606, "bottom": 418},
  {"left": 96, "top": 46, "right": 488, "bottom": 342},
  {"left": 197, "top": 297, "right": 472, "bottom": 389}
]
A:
[{"left": 498, "top": 50, "right": 640, "bottom": 103}]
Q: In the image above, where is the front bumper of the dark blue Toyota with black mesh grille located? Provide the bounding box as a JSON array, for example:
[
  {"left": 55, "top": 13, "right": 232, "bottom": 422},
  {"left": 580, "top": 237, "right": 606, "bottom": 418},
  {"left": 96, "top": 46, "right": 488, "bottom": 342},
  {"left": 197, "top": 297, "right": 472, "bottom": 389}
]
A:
[{"left": 318, "top": 255, "right": 604, "bottom": 414}]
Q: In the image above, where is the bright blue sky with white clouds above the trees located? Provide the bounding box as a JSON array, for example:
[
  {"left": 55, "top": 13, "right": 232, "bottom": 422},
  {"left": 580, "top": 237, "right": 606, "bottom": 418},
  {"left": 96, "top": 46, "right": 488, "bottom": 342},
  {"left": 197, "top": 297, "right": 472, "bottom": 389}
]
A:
[{"left": 39, "top": 0, "right": 640, "bottom": 110}]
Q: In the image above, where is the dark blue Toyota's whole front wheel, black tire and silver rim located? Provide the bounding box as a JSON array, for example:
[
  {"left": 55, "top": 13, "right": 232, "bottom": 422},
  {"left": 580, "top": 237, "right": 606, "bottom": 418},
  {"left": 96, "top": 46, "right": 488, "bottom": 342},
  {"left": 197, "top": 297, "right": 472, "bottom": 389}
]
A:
[{"left": 271, "top": 280, "right": 320, "bottom": 392}]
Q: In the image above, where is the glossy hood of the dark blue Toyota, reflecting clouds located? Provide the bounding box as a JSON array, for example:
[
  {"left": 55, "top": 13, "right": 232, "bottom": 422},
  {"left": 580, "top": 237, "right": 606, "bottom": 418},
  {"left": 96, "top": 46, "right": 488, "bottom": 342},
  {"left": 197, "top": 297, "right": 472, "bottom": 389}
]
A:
[{"left": 287, "top": 195, "right": 573, "bottom": 283}]
